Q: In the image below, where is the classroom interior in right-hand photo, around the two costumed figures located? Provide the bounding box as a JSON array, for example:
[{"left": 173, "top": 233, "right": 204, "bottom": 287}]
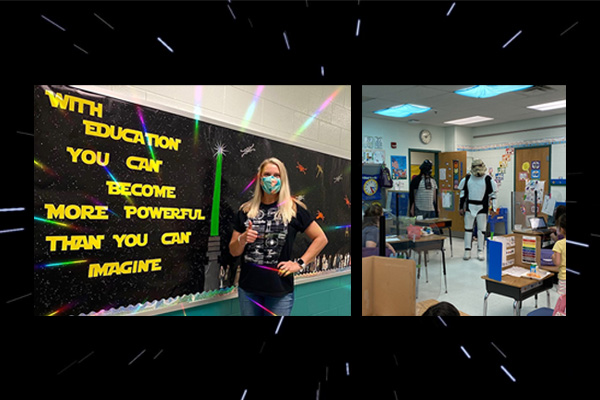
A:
[{"left": 361, "top": 85, "right": 567, "bottom": 316}]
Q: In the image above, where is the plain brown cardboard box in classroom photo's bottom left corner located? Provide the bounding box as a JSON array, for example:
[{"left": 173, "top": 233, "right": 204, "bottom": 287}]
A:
[{"left": 362, "top": 257, "right": 416, "bottom": 316}]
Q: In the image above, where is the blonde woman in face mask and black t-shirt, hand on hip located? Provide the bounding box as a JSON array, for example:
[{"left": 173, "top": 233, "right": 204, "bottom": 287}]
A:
[{"left": 229, "top": 157, "right": 327, "bottom": 316}]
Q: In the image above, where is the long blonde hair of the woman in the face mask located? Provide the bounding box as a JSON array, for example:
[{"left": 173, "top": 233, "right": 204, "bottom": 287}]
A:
[{"left": 240, "top": 157, "right": 306, "bottom": 224}]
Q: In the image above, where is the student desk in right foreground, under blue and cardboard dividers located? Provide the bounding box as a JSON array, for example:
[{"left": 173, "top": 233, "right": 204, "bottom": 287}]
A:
[{"left": 481, "top": 267, "right": 554, "bottom": 316}]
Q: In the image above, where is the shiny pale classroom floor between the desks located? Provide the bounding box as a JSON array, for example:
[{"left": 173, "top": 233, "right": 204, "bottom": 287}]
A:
[{"left": 412, "top": 237, "right": 558, "bottom": 316}]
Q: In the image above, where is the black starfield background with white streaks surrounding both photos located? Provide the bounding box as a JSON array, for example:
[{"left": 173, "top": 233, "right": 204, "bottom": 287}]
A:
[{"left": 0, "top": 1, "right": 600, "bottom": 394}]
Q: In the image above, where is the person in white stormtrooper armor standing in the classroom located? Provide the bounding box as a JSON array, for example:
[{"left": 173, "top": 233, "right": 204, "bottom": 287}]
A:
[{"left": 458, "top": 158, "right": 498, "bottom": 261}]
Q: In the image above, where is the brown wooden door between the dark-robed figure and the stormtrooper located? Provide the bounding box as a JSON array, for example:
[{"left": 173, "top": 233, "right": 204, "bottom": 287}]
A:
[{"left": 438, "top": 151, "right": 467, "bottom": 232}]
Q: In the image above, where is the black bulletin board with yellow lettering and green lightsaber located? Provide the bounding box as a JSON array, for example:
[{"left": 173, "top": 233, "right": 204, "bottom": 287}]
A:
[{"left": 34, "top": 85, "right": 351, "bottom": 315}]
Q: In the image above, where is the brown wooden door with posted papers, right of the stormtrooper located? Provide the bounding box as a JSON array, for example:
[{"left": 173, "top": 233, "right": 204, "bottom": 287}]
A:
[{"left": 515, "top": 146, "right": 550, "bottom": 219}]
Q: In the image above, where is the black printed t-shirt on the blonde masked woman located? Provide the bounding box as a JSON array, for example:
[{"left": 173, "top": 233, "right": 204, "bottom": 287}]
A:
[{"left": 233, "top": 202, "right": 314, "bottom": 297}]
